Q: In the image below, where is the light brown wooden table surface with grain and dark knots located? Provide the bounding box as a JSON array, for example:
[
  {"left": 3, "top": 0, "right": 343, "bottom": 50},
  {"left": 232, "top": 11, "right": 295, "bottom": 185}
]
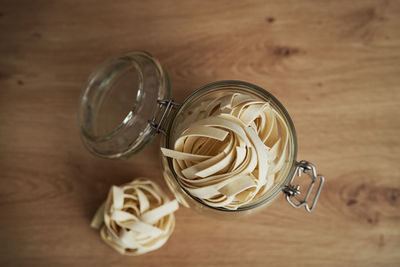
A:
[{"left": 0, "top": 0, "right": 400, "bottom": 266}]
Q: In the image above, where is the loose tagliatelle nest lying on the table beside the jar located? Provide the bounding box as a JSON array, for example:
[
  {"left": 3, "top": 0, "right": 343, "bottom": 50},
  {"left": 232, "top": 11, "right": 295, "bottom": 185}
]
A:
[{"left": 91, "top": 178, "right": 178, "bottom": 255}]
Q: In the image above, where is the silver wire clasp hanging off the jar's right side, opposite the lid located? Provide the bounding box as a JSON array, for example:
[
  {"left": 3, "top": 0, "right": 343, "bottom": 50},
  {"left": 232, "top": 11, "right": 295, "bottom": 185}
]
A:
[{"left": 283, "top": 160, "right": 325, "bottom": 212}]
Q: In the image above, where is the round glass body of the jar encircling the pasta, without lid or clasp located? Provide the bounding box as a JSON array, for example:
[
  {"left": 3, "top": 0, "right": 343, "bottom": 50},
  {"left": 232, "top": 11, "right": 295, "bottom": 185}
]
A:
[{"left": 162, "top": 81, "right": 297, "bottom": 218}]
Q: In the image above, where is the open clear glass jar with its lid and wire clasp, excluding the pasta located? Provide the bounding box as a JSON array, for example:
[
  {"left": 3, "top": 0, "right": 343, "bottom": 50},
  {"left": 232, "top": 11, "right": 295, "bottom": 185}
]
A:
[{"left": 78, "top": 52, "right": 324, "bottom": 218}]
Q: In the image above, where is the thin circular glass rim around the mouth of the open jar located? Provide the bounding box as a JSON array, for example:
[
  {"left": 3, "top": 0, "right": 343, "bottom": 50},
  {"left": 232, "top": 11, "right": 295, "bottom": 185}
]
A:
[{"left": 165, "top": 80, "right": 297, "bottom": 212}]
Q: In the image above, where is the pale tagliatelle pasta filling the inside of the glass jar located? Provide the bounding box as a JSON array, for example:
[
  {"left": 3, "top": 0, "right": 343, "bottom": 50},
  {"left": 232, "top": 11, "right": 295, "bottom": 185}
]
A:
[{"left": 161, "top": 93, "right": 289, "bottom": 210}]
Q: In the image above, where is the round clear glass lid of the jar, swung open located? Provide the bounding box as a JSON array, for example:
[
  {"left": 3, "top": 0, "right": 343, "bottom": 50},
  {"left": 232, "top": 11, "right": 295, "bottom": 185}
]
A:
[{"left": 78, "top": 52, "right": 170, "bottom": 159}]
